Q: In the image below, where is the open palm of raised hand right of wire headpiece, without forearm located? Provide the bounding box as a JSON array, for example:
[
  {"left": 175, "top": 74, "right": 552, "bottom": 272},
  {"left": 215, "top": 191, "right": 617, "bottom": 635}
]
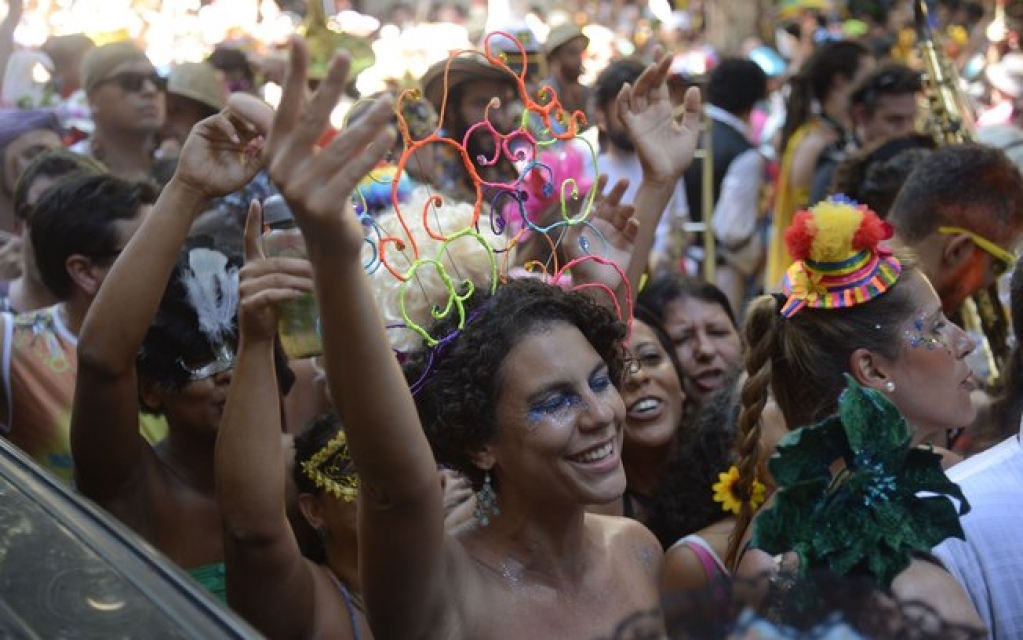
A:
[{"left": 617, "top": 55, "right": 701, "bottom": 183}]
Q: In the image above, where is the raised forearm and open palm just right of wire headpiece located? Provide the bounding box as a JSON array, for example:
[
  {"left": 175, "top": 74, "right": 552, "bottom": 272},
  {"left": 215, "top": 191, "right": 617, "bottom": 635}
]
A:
[{"left": 617, "top": 55, "right": 701, "bottom": 296}]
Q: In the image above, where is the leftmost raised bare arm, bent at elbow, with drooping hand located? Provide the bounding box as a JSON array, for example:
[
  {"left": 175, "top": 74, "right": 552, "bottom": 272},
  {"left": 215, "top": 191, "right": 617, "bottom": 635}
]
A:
[{"left": 71, "top": 112, "right": 259, "bottom": 502}]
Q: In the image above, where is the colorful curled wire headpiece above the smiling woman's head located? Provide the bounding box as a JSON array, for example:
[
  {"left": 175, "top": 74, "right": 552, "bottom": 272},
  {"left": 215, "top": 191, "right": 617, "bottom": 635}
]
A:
[{"left": 360, "top": 32, "right": 630, "bottom": 348}]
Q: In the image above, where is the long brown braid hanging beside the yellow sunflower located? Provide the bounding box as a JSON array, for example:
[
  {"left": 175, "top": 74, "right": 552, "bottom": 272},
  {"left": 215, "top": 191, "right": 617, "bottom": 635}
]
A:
[{"left": 725, "top": 295, "right": 781, "bottom": 572}]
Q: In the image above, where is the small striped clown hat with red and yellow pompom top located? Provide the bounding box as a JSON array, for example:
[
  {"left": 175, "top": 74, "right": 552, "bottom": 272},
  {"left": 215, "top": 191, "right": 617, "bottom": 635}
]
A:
[{"left": 782, "top": 195, "right": 902, "bottom": 318}]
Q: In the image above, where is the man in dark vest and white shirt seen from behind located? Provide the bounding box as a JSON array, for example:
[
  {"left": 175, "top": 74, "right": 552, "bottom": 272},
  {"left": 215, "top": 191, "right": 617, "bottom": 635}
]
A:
[{"left": 685, "top": 58, "right": 767, "bottom": 310}]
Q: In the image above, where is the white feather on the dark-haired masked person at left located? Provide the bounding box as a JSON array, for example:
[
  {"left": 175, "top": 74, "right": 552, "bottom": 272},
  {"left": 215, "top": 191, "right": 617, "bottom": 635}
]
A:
[{"left": 182, "top": 247, "right": 238, "bottom": 345}]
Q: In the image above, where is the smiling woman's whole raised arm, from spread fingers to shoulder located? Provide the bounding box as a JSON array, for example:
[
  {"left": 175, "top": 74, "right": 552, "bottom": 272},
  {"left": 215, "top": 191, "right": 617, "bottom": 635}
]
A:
[{"left": 245, "top": 40, "right": 448, "bottom": 638}]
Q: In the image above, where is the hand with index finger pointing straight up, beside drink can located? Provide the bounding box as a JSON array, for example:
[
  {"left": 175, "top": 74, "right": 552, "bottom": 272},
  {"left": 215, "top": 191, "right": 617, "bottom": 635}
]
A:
[{"left": 238, "top": 200, "right": 313, "bottom": 345}]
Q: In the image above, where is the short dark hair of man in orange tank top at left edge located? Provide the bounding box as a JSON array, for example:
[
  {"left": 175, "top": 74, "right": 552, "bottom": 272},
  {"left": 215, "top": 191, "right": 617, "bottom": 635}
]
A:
[{"left": 32, "top": 174, "right": 157, "bottom": 300}]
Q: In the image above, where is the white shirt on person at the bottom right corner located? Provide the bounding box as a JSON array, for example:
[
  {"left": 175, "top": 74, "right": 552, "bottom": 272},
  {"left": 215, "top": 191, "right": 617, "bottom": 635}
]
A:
[{"left": 934, "top": 436, "right": 1023, "bottom": 640}]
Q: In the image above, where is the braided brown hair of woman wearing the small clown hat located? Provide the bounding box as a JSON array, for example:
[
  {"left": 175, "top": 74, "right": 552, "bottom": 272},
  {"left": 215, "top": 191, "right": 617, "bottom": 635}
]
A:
[{"left": 726, "top": 252, "right": 924, "bottom": 566}]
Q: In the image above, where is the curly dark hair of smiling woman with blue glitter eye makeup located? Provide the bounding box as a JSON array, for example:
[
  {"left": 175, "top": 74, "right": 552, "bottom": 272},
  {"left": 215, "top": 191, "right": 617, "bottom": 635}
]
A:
[{"left": 404, "top": 278, "right": 625, "bottom": 489}]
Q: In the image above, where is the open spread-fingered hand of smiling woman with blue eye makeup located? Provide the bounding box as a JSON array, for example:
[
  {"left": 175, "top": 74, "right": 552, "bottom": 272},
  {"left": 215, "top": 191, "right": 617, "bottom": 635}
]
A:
[{"left": 255, "top": 39, "right": 396, "bottom": 254}]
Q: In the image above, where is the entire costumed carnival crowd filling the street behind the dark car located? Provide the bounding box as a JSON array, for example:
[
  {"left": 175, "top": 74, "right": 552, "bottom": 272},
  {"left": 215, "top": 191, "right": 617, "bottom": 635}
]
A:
[{"left": 0, "top": 0, "right": 1023, "bottom": 639}]
